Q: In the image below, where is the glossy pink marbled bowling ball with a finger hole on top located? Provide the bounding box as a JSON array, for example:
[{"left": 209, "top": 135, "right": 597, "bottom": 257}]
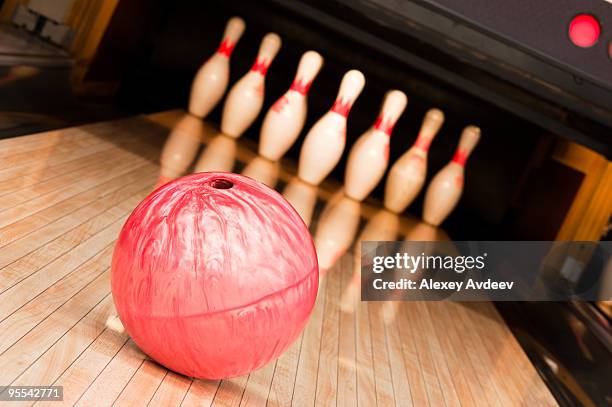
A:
[{"left": 111, "top": 173, "right": 319, "bottom": 379}]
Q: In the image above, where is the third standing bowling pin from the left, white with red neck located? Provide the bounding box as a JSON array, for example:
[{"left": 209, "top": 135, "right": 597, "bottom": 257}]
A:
[{"left": 259, "top": 51, "right": 323, "bottom": 161}]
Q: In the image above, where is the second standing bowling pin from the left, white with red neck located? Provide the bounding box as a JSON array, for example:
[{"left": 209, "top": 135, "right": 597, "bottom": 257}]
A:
[{"left": 221, "top": 33, "right": 281, "bottom": 137}]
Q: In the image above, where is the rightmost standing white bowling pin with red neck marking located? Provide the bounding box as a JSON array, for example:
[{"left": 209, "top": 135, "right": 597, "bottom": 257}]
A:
[{"left": 423, "top": 126, "right": 480, "bottom": 226}]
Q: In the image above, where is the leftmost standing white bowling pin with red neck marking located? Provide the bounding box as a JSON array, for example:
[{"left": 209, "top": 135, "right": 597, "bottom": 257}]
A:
[{"left": 189, "top": 17, "right": 244, "bottom": 118}]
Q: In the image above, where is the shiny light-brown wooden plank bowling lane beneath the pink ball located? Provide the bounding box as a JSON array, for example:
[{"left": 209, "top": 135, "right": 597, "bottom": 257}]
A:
[{"left": 0, "top": 111, "right": 556, "bottom": 406}]
